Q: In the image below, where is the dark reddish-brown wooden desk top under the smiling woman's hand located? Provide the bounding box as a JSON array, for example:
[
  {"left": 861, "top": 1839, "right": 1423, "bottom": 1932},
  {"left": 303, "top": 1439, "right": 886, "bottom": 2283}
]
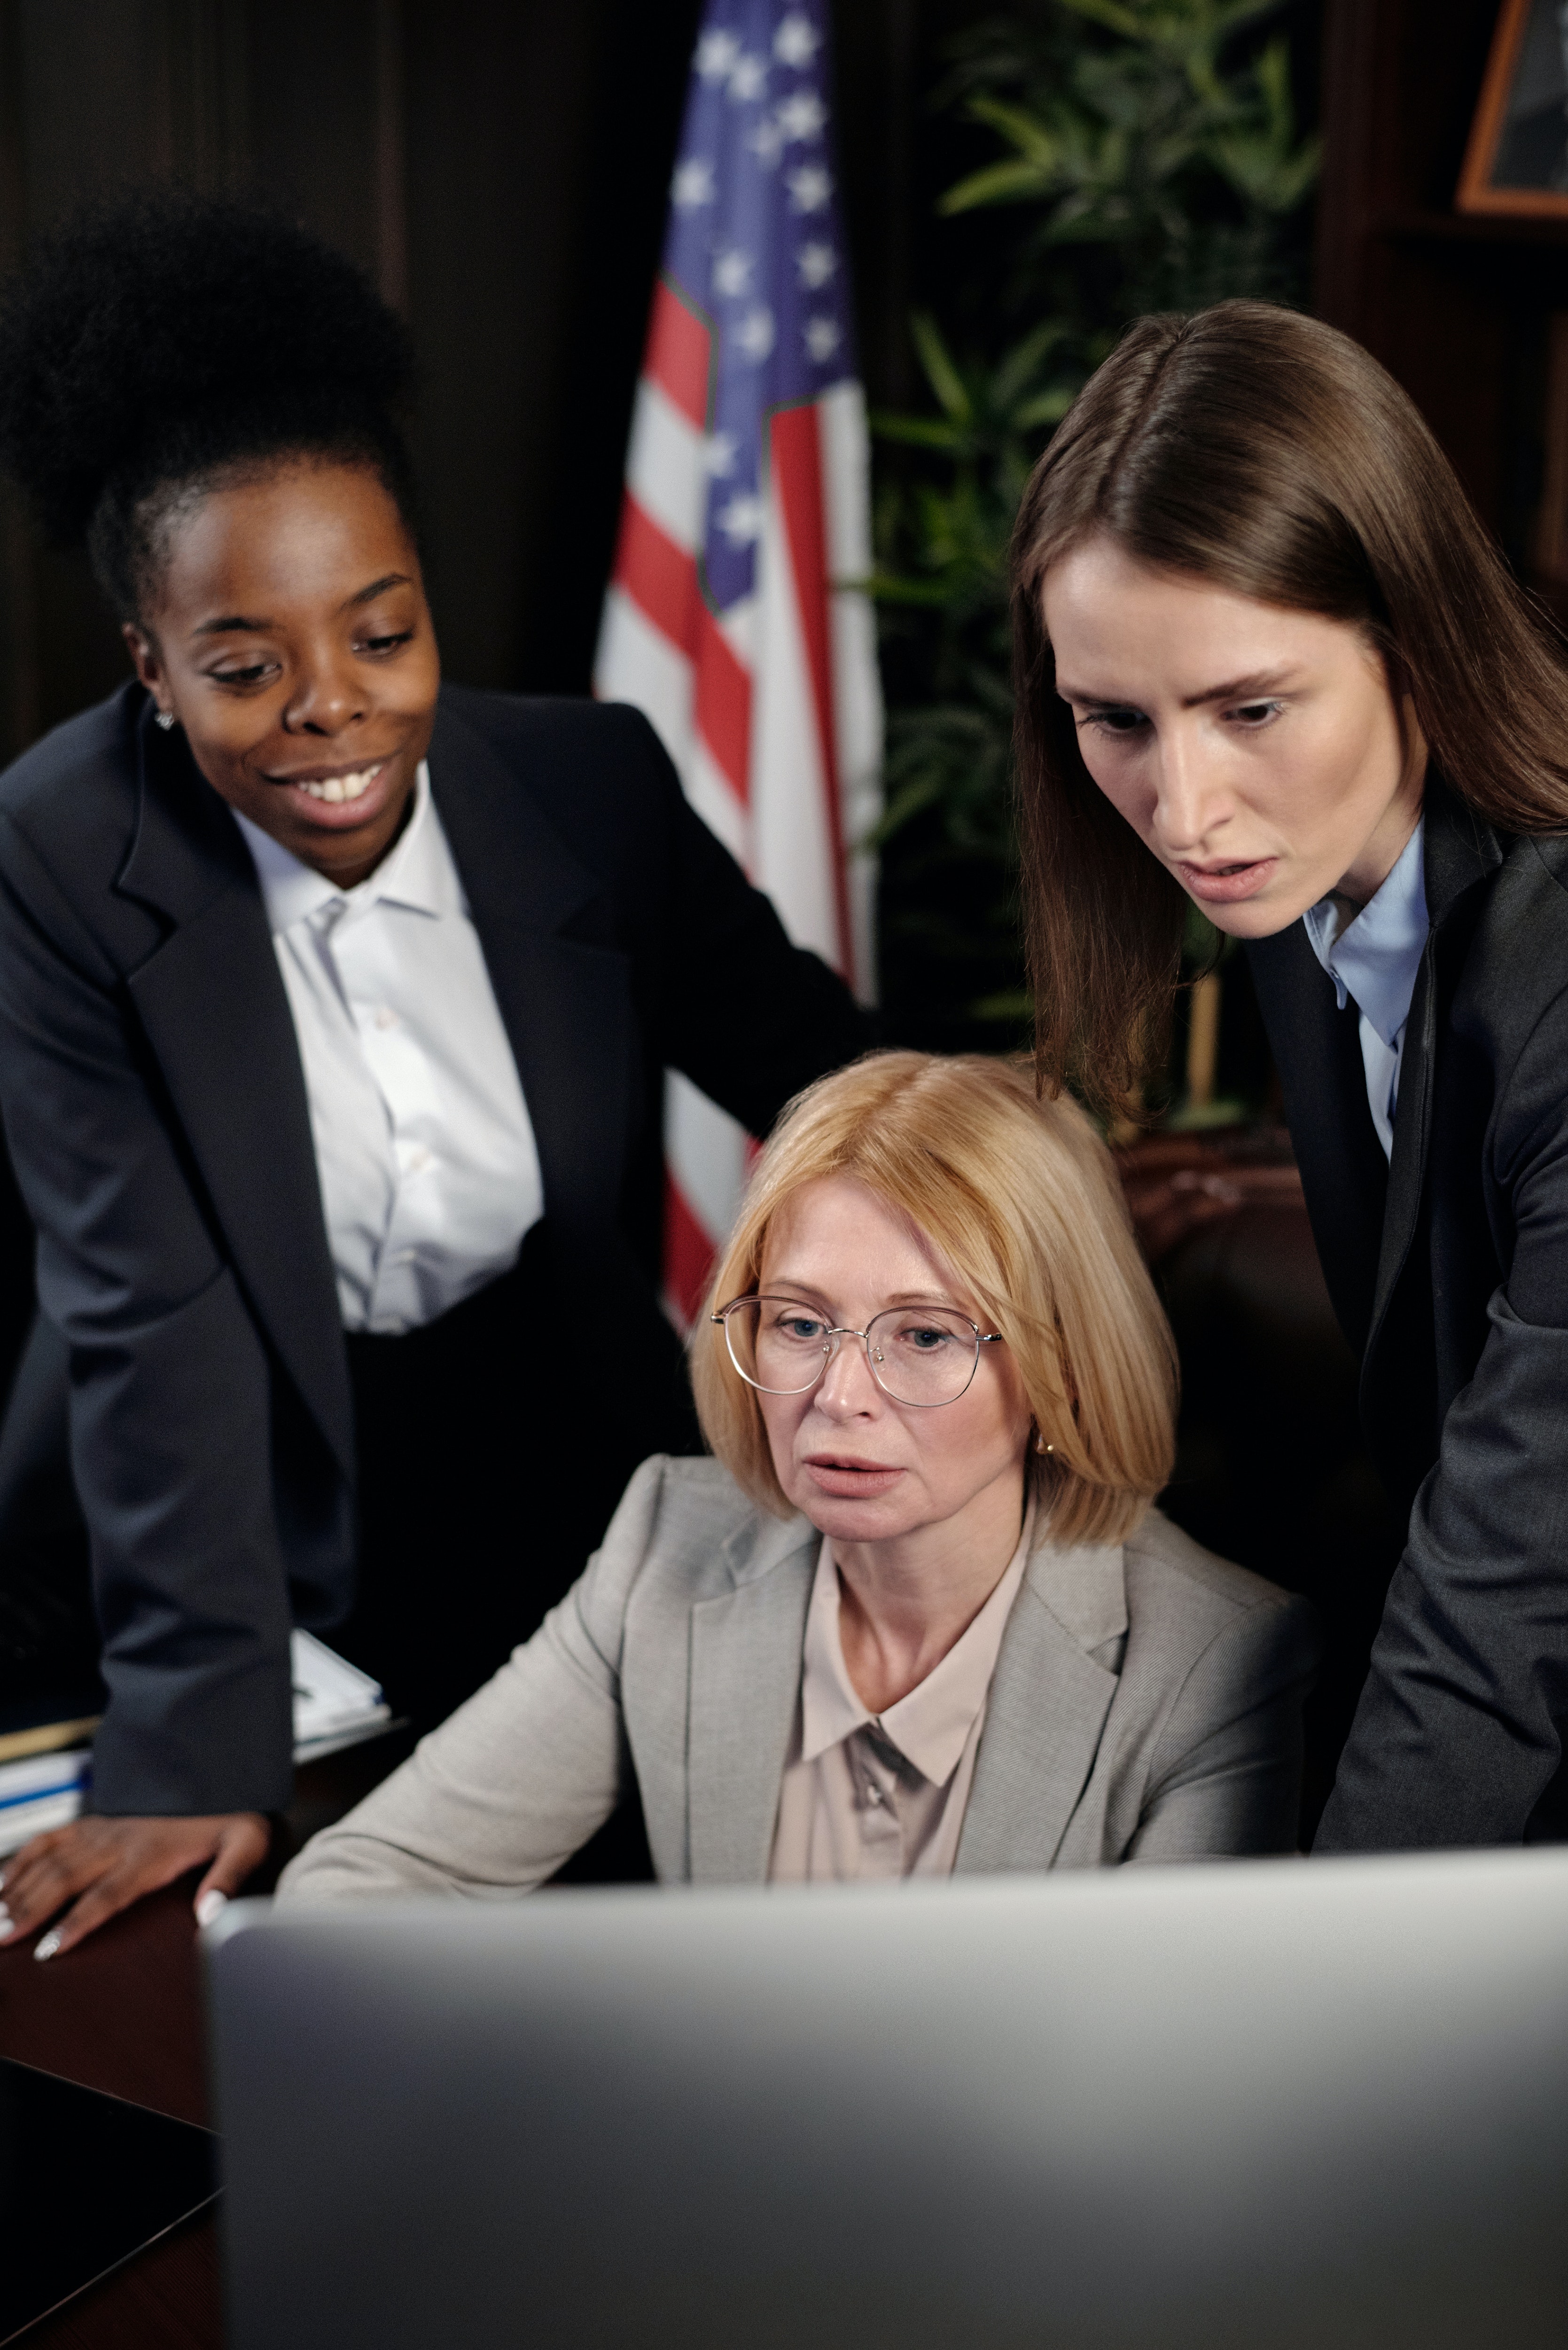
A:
[{"left": 0, "top": 1732, "right": 409, "bottom": 2350}]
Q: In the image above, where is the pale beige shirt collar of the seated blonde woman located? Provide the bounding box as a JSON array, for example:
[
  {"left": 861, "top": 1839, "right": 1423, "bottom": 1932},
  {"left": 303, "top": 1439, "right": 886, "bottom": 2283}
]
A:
[{"left": 802, "top": 1502, "right": 1034, "bottom": 1786}]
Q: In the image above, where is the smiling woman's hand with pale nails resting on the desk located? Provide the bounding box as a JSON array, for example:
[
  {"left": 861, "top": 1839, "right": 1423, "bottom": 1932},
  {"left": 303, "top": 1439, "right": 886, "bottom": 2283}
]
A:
[{"left": 0, "top": 1812, "right": 270, "bottom": 1958}]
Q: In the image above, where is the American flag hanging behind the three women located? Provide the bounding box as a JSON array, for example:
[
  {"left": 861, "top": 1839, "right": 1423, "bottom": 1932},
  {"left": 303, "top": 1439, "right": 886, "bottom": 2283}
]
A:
[{"left": 595, "top": 0, "right": 882, "bottom": 1328}]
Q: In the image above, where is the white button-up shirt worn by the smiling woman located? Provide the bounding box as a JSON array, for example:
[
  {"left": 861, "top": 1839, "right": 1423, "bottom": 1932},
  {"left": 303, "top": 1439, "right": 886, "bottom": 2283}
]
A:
[{"left": 240, "top": 761, "right": 546, "bottom": 1335}]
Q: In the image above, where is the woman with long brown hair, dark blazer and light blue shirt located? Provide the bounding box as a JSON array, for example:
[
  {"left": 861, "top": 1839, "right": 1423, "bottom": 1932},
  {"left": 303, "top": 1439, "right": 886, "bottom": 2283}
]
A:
[{"left": 1013, "top": 303, "right": 1568, "bottom": 1852}]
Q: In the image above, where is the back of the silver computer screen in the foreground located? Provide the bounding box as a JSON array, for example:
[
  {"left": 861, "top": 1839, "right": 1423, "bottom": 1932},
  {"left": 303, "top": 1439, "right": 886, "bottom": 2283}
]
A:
[{"left": 209, "top": 1852, "right": 1568, "bottom": 2350}]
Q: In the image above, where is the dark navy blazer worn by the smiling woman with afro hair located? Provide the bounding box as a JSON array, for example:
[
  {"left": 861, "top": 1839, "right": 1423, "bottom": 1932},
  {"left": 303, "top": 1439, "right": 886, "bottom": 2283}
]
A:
[{"left": 0, "top": 686, "right": 870, "bottom": 1812}]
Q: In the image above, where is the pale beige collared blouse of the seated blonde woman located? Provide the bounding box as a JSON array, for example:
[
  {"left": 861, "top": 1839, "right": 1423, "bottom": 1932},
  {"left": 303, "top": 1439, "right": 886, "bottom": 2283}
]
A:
[{"left": 769, "top": 1506, "right": 1034, "bottom": 1885}]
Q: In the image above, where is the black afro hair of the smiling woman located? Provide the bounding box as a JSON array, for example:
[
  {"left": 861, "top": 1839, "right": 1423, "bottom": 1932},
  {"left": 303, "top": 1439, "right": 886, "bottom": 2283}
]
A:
[{"left": 0, "top": 190, "right": 414, "bottom": 618}]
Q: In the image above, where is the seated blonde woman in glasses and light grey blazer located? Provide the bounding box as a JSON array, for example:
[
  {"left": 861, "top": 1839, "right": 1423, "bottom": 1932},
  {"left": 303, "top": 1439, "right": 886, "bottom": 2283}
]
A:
[{"left": 280, "top": 1053, "right": 1317, "bottom": 1899}]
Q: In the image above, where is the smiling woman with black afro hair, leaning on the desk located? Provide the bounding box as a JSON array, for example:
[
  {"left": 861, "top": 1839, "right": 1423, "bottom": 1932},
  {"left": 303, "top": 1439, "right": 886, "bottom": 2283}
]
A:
[{"left": 0, "top": 195, "right": 867, "bottom": 1955}]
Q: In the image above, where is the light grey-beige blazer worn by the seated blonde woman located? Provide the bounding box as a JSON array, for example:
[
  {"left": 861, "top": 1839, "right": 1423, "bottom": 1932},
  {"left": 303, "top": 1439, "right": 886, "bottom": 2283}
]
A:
[{"left": 277, "top": 1457, "right": 1319, "bottom": 1901}]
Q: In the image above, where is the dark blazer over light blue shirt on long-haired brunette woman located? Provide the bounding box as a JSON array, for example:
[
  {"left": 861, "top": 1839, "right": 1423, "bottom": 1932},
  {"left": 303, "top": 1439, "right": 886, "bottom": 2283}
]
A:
[{"left": 1248, "top": 780, "right": 1568, "bottom": 1852}]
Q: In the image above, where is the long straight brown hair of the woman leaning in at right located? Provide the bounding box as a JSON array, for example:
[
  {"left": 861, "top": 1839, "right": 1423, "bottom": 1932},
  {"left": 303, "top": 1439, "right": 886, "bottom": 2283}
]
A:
[{"left": 1013, "top": 301, "right": 1568, "bottom": 1114}]
